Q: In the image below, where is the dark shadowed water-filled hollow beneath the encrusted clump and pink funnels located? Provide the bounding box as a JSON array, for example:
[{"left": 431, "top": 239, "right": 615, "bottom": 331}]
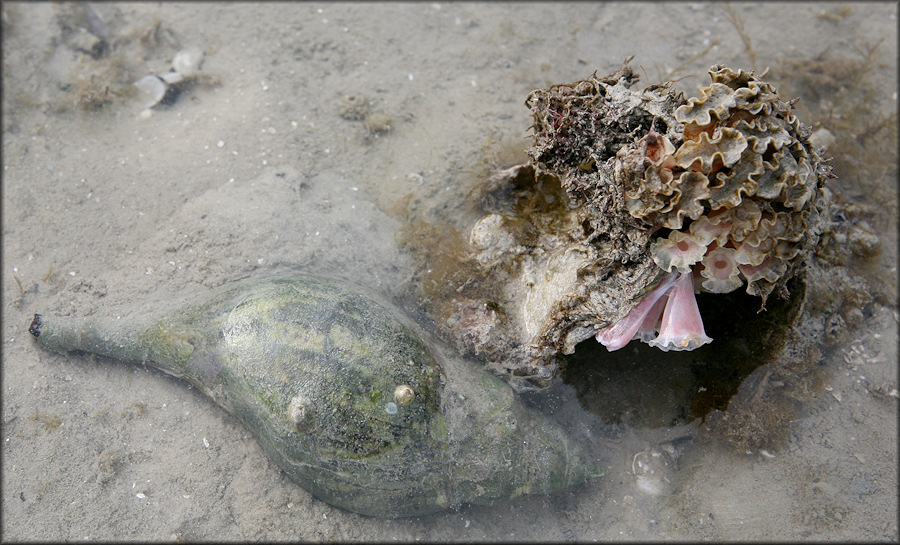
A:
[{"left": 561, "top": 280, "right": 804, "bottom": 428}]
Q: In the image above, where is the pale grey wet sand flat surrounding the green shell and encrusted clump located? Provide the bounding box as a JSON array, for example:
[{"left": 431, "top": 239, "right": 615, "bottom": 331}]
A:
[{"left": 3, "top": 3, "right": 897, "bottom": 541}]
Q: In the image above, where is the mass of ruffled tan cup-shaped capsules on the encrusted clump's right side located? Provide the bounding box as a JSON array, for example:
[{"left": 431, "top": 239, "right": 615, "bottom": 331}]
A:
[{"left": 616, "top": 66, "right": 825, "bottom": 302}]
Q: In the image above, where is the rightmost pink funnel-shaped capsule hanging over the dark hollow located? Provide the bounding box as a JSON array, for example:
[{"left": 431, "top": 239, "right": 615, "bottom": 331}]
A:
[{"left": 647, "top": 272, "right": 712, "bottom": 352}]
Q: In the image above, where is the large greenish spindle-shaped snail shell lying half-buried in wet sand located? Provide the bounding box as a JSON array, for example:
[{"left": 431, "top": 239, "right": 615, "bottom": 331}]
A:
[{"left": 31, "top": 276, "right": 601, "bottom": 517}]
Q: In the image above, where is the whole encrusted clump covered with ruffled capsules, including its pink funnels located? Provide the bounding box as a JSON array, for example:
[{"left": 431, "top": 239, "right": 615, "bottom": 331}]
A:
[{"left": 450, "top": 61, "right": 830, "bottom": 388}]
